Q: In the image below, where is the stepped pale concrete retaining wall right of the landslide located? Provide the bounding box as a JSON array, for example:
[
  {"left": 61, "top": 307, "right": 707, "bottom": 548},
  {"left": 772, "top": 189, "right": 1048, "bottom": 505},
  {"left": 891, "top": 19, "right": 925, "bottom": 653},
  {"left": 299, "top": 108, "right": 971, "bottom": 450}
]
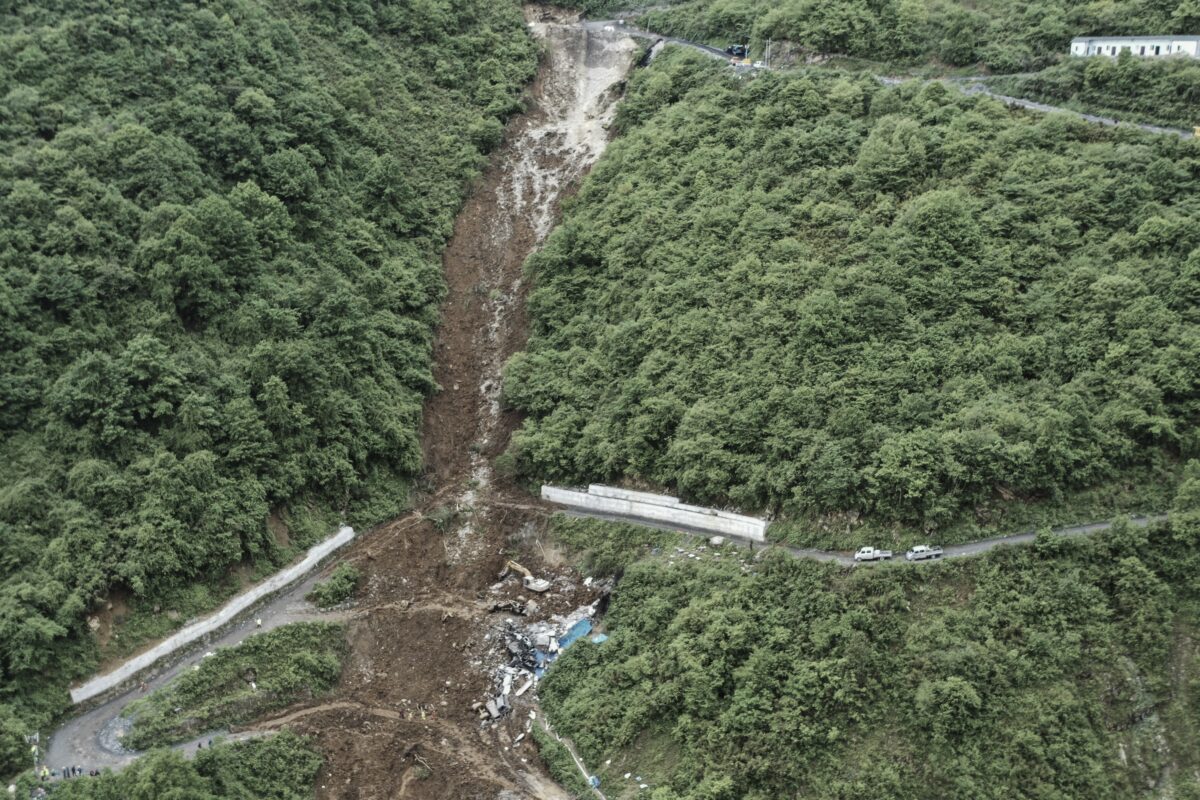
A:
[{"left": 541, "top": 483, "right": 767, "bottom": 542}]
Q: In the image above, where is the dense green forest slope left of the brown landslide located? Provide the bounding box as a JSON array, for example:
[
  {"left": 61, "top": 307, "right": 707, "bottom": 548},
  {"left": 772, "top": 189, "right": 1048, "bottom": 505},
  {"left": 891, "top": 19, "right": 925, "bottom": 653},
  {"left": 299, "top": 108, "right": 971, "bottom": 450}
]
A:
[{"left": 0, "top": 0, "right": 536, "bottom": 777}]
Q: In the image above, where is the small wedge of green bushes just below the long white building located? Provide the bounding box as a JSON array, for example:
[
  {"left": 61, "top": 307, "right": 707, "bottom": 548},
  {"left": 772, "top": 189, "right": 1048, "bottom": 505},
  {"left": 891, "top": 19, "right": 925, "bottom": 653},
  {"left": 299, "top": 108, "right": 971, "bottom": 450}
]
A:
[{"left": 989, "top": 53, "right": 1200, "bottom": 130}]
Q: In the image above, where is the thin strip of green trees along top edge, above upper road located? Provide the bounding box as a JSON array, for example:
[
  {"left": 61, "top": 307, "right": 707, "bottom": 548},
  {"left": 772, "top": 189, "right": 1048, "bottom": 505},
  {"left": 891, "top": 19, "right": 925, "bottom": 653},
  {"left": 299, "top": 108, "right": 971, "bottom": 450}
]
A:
[{"left": 590, "top": 0, "right": 1200, "bottom": 72}]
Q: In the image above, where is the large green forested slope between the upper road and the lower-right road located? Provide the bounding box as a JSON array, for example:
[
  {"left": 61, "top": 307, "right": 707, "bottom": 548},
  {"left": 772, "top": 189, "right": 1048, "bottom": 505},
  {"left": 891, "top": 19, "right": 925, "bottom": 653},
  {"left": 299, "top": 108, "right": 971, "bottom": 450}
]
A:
[{"left": 505, "top": 50, "right": 1200, "bottom": 546}]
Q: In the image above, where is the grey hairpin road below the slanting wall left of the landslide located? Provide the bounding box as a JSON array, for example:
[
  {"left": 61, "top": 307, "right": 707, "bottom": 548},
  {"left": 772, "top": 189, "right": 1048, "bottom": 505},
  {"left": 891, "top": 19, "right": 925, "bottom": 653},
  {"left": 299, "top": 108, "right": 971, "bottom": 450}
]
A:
[{"left": 43, "top": 570, "right": 348, "bottom": 771}]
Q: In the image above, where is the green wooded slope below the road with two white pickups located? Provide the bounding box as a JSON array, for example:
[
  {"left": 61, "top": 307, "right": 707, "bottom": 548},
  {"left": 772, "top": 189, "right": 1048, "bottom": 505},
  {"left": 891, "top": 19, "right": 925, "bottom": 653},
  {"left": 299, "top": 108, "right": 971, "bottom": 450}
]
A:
[{"left": 539, "top": 463, "right": 1200, "bottom": 800}]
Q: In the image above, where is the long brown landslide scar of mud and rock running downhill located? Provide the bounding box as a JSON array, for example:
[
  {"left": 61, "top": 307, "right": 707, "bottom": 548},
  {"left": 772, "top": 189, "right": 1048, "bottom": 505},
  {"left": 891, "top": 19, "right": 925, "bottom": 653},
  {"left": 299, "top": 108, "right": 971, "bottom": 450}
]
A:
[{"left": 254, "top": 8, "right": 637, "bottom": 800}]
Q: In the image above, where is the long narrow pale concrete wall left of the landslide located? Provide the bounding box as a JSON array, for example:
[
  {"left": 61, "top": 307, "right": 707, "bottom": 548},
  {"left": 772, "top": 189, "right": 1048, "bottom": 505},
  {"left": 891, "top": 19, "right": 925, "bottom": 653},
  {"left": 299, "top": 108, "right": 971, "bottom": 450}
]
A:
[{"left": 71, "top": 527, "right": 354, "bottom": 704}]
